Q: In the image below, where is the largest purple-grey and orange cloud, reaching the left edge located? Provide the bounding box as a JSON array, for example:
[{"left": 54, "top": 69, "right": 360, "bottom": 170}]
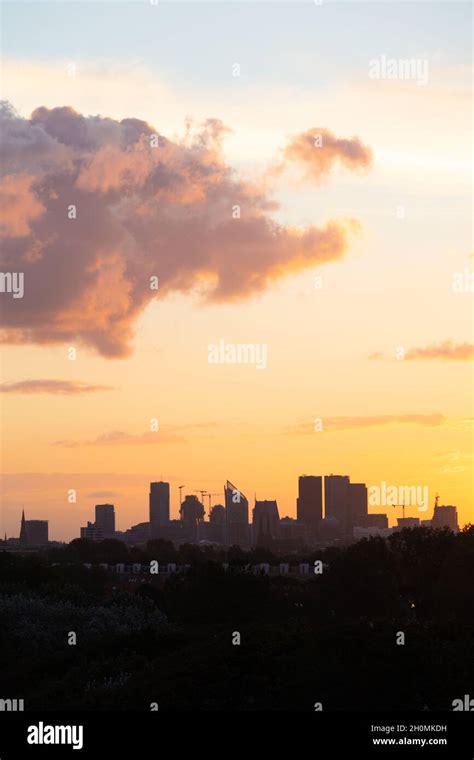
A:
[{"left": 0, "top": 105, "right": 365, "bottom": 357}]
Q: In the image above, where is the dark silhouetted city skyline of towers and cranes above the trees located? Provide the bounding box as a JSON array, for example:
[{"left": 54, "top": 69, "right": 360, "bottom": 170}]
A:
[{"left": 6, "top": 474, "right": 463, "bottom": 546}]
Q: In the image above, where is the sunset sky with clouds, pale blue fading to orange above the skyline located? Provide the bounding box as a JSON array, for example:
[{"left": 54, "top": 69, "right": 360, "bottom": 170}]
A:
[{"left": 0, "top": 0, "right": 474, "bottom": 540}]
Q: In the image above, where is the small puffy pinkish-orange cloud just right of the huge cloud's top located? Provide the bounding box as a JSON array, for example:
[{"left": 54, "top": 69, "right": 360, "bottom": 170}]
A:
[{"left": 284, "top": 128, "right": 372, "bottom": 181}]
